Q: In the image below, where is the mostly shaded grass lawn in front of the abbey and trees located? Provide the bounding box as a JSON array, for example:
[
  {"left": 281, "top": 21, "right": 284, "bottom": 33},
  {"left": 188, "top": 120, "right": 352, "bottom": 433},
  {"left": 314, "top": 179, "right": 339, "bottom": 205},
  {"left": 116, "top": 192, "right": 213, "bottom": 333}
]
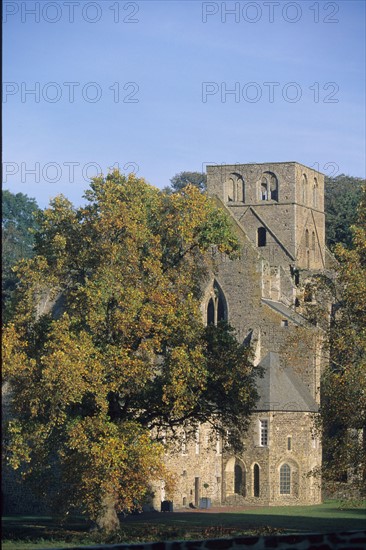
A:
[{"left": 2, "top": 501, "right": 366, "bottom": 550}]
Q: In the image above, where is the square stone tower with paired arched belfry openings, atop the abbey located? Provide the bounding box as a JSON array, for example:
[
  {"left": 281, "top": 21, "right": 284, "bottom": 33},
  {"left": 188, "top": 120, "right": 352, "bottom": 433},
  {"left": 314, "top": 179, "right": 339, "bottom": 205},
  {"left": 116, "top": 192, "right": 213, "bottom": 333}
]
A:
[{"left": 207, "top": 162, "right": 325, "bottom": 269}]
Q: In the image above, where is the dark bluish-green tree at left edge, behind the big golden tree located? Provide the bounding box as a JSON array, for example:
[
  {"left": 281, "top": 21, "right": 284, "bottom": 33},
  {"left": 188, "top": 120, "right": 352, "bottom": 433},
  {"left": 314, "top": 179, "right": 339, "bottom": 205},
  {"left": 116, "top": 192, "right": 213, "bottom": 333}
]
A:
[{"left": 2, "top": 190, "right": 39, "bottom": 319}]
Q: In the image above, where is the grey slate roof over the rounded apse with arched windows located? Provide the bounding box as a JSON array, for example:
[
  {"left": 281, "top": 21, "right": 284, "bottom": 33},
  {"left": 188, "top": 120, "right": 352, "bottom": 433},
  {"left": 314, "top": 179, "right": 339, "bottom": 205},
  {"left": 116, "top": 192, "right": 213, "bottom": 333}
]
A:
[{"left": 256, "top": 352, "right": 318, "bottom": 412}]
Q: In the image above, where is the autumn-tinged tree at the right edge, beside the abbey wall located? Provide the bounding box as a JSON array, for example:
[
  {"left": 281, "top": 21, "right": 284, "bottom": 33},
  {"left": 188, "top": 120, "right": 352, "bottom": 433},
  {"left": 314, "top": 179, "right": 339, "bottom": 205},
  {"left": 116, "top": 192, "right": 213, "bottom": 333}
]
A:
[{"left": 322, "top": 185, "right": 366, "bottom": 492}]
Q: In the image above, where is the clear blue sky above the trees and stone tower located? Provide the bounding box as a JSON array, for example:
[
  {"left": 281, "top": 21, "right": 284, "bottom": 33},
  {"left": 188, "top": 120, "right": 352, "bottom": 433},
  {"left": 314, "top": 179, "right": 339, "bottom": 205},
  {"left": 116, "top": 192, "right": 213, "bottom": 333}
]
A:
[{"left": 3, "top": 0, "right": 365, "bottom": 207}]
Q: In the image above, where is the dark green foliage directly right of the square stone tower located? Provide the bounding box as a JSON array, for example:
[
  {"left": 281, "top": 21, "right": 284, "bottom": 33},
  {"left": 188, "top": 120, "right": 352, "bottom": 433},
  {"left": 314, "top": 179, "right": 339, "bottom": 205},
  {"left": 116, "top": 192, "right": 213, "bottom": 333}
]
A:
[{"left": 324, "top": 174, "right": 364, "bottom": 249}]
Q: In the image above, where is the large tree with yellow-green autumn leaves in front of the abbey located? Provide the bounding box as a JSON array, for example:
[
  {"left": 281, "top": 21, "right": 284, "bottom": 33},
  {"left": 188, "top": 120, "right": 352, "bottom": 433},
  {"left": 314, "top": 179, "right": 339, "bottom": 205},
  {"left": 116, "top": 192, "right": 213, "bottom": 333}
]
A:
[{"left": 3, "top": 172, "right": 256, "bottom": 529}]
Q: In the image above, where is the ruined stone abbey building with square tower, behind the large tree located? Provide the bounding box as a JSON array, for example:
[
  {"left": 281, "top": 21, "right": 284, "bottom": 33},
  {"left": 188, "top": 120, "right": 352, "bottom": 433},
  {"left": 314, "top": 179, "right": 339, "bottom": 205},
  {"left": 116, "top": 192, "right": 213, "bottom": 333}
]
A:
[{"left": 154, "top": 162, "right": 329, "bottom": 509}]
